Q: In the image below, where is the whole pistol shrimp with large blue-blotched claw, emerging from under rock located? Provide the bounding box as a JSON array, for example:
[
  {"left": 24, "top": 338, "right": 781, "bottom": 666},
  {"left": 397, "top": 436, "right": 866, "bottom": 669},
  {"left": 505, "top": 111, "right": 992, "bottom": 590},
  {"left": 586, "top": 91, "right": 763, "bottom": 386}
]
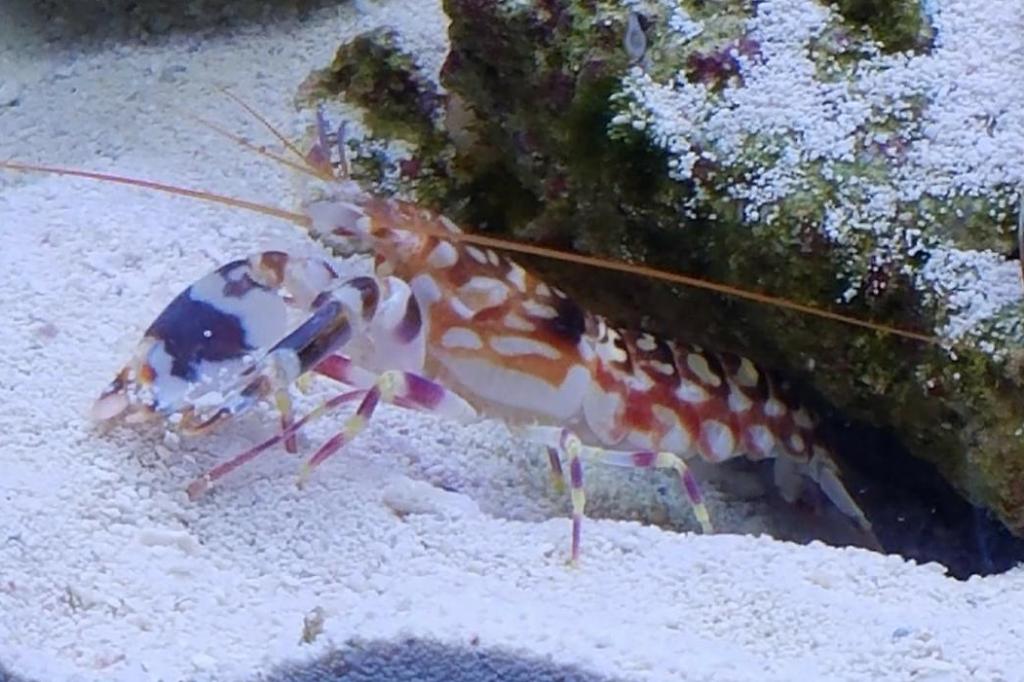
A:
[{"left": 3, "top": 110, "right": 888, "bottom": 562}]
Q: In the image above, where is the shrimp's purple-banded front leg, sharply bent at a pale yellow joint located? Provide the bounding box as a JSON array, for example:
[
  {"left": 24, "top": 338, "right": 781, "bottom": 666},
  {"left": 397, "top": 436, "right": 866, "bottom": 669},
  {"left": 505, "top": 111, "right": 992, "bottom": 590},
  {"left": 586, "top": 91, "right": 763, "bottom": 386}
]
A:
[{"left": 299, "top": 370, "right": 476, "bottom": 487}]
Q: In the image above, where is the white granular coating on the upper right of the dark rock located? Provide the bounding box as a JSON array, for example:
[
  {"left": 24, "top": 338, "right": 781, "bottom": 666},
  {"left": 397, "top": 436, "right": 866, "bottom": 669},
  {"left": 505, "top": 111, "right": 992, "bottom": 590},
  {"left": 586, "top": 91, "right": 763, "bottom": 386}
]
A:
[{"left": 609, "top": 0, "right": 1024, "bottom": 348}]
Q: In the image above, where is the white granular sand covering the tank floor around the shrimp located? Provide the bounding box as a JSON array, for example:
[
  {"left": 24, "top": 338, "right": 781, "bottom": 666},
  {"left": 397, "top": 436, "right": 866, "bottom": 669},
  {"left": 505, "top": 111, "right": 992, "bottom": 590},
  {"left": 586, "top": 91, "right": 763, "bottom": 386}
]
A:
[{"left": 0, "top": 0, "right": 1024, "bottom": 682}]
